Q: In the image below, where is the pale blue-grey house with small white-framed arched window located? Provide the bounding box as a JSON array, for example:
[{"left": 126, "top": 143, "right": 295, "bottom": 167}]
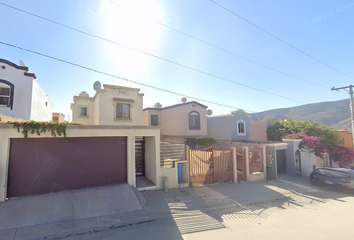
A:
[{"left": 207, "top": 109, "right": 250, "bottom": 141}]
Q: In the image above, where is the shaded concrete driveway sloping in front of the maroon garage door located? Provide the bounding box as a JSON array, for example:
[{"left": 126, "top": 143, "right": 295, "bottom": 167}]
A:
[{"left": 0, "top": 184, "right": 142, "bottom": 230}]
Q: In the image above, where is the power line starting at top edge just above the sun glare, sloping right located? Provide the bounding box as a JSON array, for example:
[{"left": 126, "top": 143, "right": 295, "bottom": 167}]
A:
[{"left": 109, "top": 0, "right": 328, "bottom": 88}]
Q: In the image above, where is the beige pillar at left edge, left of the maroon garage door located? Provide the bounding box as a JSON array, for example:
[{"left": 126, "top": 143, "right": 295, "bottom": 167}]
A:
[{"left": 0, "top": 137, "right": 10, "bottom": 202}]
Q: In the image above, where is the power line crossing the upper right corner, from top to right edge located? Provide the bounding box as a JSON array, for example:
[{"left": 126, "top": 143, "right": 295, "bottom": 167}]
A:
[{"left": 210, "top": 0, "right": 354, "bottom": 78}]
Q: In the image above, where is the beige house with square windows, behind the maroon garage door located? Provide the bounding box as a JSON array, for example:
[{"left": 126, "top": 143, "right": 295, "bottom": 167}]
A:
[{"left": 71, "top": 84, "right": 144, "bottom": 126}]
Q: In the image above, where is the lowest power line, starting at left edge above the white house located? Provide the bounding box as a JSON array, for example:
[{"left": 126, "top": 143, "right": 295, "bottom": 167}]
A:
[{"left": 0, "top": 41, "right": 255, "bottom": 112}]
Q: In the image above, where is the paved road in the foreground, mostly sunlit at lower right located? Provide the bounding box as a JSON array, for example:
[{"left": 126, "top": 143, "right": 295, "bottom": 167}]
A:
[{"left": 63, "top": 189, "right": 354, "bottom": 240}]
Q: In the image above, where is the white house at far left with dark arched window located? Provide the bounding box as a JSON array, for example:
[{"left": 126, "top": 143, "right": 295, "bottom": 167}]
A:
[{"left": 0, "top": 59, "right": 53, "bottom": 121}]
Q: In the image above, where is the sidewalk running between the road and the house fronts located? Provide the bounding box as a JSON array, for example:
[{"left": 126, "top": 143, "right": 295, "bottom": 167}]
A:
[{"left": 0, "top": 175, "right": 342, "bottom": 239}]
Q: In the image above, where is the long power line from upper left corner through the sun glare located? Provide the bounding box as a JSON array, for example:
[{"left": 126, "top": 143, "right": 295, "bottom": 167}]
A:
[{"left": 0, "top": 2, "right": 306, "bottom": 103}]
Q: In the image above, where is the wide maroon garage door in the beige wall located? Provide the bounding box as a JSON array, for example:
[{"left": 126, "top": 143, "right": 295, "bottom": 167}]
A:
[{"left": 7, "top": 137, "right": 127, "bottom": 198}]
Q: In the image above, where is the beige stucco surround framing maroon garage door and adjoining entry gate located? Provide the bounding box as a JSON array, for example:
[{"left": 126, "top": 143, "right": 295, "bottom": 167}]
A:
[{"left": 0, "top": 124, "right": 161, "bottom": 202}]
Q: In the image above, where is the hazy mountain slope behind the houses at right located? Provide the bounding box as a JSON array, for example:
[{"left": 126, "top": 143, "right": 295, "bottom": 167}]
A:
[{"left": 250, "top": 99, "right": 351, "bottom": 129}]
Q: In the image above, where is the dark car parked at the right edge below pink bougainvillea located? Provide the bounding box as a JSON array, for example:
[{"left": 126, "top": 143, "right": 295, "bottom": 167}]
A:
[{"left": 310, "top": 167, "right": 354, "bottom": 190}]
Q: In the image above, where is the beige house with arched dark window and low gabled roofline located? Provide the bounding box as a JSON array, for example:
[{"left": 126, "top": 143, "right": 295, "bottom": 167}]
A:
[{"left": 143, "top": 101, "right": 208, "bottom": 145}]
